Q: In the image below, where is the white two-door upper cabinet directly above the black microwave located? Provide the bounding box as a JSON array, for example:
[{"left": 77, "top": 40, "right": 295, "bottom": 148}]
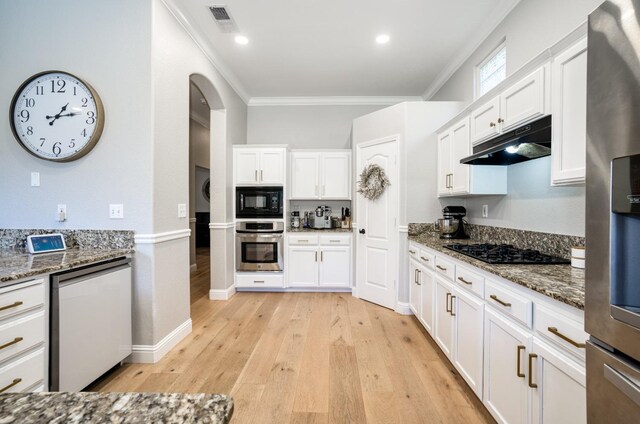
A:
[{"left": 233, "top": 147, "right": 286, "bottom": 186}]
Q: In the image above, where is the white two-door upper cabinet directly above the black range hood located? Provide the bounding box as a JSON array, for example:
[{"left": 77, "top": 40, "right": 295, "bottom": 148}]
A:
[{"left": 471, "top": 65, "right": 549, "bottom": 145}]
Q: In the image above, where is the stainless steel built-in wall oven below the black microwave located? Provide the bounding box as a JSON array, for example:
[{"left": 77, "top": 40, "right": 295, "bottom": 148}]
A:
[{"left": 236, "top": 222, "right": 284, "bottom": 272}]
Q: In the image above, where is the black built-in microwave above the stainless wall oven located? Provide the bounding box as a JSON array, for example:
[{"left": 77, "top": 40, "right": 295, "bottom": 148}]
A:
[{"left": 236, "top": 187, "right": 283, "bottom": 219}]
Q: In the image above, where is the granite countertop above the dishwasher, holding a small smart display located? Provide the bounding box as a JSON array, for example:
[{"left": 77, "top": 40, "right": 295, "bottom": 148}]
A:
[{"left": 0, "top": 249, "right": 133, "bottom": 284}]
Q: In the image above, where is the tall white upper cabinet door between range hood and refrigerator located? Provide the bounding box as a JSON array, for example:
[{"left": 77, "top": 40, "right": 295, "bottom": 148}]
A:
[{"left": 551, "top": 38, "right": 587, "bottom": 185}]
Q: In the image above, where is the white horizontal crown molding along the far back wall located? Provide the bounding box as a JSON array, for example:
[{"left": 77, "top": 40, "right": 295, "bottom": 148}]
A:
[{"left": 248, "top": 96, "right": 422, "bottom": 106}]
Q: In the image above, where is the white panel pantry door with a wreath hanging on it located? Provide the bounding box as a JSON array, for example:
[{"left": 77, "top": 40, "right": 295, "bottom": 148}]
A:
[{"left": 356, "top": 138, "right": 399, "bottom": 309}]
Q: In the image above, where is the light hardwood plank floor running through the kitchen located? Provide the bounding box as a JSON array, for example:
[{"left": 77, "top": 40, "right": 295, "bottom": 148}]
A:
[{"left": 88, "top": 250, "right": 494, "bottom": 424}]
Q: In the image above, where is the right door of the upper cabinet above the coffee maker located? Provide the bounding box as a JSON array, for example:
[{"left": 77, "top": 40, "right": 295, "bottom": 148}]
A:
[{"left": 320, "top": 152, "right": 351, "bottom": 200}]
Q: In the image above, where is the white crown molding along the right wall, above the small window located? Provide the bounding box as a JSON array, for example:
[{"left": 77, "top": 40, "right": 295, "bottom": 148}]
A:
[{"left": 422, "top": 0, "right": 520, "bottom": 100}]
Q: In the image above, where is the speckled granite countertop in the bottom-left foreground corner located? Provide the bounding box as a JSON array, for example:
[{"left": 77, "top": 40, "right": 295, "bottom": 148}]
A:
[{"left": 0, "top": 392, "right": 233, "bottom": 424}]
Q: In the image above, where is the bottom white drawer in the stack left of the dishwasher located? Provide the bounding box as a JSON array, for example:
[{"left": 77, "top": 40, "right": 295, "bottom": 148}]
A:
[{"left": 0, "top": 349, "right": 44, "bottom": 393}]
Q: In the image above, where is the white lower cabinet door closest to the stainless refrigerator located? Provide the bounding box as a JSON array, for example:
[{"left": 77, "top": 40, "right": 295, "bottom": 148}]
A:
[{"left": 529, "top": 338, "right": 587, "bottom": 424}]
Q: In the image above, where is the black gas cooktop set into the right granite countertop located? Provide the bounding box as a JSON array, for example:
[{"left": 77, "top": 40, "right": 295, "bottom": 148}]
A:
[{"left": 444, "top": 244, "right": 571, "bottom": 265}]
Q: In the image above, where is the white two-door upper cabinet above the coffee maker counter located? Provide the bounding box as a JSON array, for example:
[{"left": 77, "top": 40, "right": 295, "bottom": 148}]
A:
[{"left": 289, "top": 150, "right": 351, "bottom": 200}]
